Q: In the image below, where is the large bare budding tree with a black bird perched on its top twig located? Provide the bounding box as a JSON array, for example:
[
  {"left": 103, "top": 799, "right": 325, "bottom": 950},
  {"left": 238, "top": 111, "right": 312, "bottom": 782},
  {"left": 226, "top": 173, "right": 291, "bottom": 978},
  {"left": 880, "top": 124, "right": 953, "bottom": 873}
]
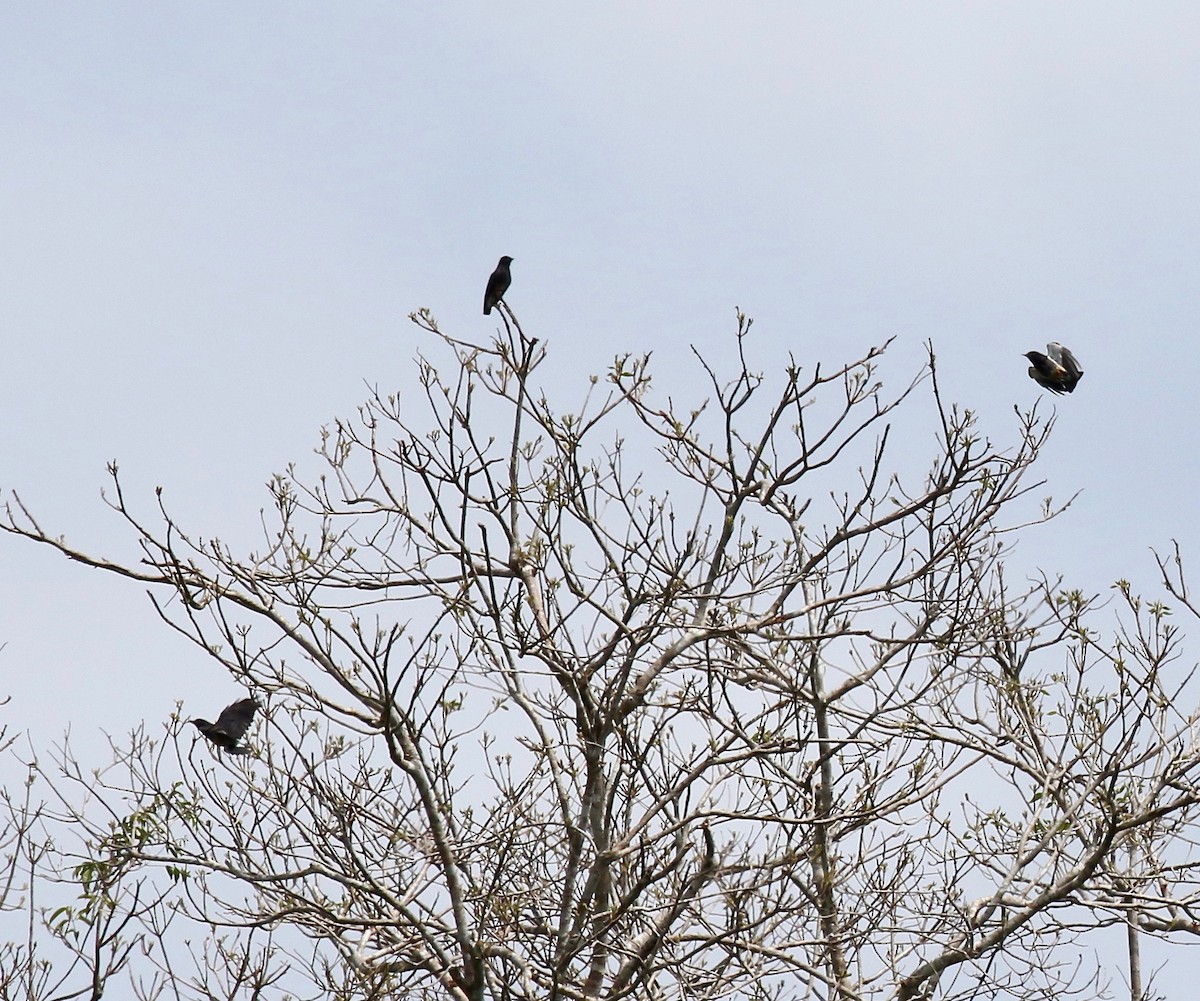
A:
[{"left": 6, "top": 310, "right": 1200, "bottom": 1001}]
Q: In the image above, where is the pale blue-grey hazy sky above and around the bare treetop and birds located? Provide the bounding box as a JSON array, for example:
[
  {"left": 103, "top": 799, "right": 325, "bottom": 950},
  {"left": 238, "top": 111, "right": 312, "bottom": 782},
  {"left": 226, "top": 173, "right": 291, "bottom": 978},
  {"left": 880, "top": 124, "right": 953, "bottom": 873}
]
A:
[{"left": 0, "top": 0, "right": 1200, "bottom": 988}]
